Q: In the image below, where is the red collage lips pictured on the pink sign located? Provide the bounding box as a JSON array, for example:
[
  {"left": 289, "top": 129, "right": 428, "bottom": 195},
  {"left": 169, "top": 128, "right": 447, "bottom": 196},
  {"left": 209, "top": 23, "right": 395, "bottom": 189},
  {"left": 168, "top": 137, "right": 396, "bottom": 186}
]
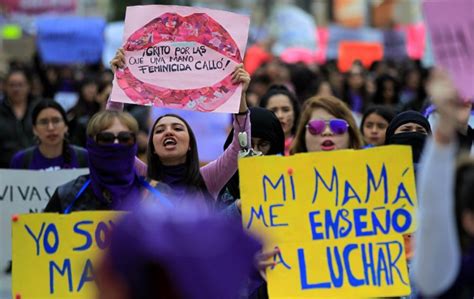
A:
[{"left": 116, "top": 13, "right": 242, "bottom": 111}]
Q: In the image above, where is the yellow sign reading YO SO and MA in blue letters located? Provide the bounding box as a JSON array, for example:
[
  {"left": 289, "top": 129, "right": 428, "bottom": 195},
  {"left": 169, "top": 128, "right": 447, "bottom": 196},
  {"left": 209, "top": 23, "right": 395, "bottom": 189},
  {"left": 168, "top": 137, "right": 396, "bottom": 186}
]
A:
[{"left": 12, "top": 211, "right": 120, "bottom": 299}]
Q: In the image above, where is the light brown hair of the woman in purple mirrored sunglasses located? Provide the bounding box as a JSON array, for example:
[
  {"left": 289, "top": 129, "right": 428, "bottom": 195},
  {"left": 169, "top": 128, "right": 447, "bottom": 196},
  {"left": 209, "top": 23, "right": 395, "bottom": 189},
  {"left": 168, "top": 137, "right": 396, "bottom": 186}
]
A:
[{"left": 290, "top": 96, "right": 364, "bottom": 154}]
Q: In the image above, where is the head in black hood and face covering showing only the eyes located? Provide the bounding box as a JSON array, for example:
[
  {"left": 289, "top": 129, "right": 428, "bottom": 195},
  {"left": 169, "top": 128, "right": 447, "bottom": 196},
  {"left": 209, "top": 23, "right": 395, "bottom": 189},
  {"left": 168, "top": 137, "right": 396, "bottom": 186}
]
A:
[{"left": 385, "top": 111, "right": 431, "bottom": 166}]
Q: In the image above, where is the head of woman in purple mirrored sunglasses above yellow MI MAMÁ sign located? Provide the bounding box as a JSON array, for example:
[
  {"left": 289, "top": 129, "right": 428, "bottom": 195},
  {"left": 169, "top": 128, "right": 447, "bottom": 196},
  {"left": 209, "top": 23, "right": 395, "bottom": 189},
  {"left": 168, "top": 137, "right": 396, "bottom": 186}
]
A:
[{"left": 291, "top": 96, "right": 363, "bottom": 154}]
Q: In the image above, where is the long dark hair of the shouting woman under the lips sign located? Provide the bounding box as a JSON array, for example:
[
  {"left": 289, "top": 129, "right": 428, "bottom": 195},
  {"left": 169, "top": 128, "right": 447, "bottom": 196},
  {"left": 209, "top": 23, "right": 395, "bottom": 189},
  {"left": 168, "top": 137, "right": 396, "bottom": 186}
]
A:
[{"left": 147, "top": 114, "right": 208, "bottom": 192}]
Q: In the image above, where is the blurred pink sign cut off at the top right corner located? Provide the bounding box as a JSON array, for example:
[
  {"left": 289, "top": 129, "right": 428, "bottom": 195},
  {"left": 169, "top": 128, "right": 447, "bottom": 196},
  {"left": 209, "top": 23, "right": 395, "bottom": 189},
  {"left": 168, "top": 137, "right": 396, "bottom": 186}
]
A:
[{"left": 423, "top": 0, "right": 474, "bottom": 101}]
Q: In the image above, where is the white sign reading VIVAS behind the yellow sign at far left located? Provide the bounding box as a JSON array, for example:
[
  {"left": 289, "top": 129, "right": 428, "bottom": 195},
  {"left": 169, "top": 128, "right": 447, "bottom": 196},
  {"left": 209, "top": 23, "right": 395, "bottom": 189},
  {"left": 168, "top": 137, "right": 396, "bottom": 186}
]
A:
[{"left": 0, "top": 169, "right": 89, "bottom": 292}]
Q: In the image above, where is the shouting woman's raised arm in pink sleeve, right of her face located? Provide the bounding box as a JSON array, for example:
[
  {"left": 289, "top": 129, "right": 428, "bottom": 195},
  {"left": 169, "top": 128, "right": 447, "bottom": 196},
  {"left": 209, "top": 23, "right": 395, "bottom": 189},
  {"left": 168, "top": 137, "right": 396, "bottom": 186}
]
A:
[{"left": 201, "top": 65, "right": 251, "bottom": 199}]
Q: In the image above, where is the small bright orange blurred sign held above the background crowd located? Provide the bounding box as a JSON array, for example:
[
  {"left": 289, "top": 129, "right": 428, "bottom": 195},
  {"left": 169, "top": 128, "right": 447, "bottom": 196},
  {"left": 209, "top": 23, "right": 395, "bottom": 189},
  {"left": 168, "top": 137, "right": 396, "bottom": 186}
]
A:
[{"left": 338, "top": 41, "right": 384, "bottom": 72}]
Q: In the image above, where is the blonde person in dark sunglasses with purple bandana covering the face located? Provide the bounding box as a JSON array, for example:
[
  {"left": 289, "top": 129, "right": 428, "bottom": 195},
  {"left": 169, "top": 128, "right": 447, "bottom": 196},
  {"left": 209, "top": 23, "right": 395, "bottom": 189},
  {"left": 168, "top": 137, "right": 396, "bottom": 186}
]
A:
[{"left": 45, "top": 111, "right": 148, "bottom": 214}]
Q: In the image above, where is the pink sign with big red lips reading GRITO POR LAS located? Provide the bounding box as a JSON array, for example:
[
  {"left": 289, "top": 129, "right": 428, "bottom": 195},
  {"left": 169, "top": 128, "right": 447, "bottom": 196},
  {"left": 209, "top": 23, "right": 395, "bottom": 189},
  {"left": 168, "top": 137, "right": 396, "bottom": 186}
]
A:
[{"left": 112, "top": 5, "right": 250, "bottom": 112}]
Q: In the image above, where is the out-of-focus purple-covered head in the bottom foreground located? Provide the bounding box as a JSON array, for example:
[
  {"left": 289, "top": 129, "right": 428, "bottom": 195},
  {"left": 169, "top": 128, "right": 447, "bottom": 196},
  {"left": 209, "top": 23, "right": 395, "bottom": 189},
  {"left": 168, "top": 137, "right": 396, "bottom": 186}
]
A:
[{"left": 95, "top": 201, "right": 261, "bottom": 299}]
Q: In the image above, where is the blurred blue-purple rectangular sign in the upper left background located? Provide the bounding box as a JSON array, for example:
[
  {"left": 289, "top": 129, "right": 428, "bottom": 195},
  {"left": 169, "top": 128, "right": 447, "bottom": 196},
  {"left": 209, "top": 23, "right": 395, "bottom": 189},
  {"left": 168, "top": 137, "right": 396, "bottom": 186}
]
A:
[{"left": 36, "top": 17, "right": 105, "bottom": 64}]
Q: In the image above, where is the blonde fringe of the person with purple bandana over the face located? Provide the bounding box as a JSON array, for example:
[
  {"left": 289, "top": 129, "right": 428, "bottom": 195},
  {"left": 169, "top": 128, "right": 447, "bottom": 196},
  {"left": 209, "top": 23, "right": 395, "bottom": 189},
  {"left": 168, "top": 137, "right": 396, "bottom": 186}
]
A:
[{"left": 87, "top": 110, "right": 138, "bottom": 137}]
